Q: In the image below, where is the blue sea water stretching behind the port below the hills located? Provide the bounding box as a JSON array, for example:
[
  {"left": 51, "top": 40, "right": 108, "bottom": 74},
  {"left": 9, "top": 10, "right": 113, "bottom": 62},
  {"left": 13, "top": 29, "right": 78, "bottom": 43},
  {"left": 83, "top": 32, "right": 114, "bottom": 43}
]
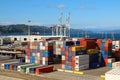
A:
[{"left": 0, "top": 33, "right": 120, "bottom": 40}]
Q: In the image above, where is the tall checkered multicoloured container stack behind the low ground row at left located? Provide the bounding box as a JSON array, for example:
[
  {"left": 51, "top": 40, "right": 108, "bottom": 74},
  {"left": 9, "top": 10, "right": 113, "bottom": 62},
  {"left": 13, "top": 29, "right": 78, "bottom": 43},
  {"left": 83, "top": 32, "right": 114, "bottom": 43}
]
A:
[{"left": 25, "top": 41, "right": 55, "bottom": 65}]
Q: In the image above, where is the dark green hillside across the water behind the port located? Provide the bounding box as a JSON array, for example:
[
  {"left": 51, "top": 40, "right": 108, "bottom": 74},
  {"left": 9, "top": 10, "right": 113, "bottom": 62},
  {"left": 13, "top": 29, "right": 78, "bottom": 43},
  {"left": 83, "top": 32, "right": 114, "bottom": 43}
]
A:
[{"left": 0, "top": 24, "right": 90, "bottom": 35}]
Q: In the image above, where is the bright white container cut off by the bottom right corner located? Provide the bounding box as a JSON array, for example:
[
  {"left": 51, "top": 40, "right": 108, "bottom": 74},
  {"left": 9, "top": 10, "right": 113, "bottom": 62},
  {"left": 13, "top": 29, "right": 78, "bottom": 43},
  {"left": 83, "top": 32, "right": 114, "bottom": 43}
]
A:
[{"left": 105, "top": 67, "right": 120, "bottom": 80}]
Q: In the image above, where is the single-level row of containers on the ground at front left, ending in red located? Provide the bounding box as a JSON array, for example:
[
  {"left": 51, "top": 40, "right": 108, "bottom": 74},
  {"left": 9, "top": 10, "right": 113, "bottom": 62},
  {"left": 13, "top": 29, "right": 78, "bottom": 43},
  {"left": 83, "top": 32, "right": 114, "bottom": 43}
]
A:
[{"left": 1, "top": 62, "right": 54, "bottom": 74}]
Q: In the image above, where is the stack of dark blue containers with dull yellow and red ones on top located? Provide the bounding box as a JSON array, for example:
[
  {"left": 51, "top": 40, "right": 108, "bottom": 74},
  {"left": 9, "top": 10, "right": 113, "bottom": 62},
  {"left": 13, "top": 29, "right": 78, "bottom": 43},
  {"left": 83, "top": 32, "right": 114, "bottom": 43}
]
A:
[{"left": 79, "top": 38, "right": 100, "bottom": 68}]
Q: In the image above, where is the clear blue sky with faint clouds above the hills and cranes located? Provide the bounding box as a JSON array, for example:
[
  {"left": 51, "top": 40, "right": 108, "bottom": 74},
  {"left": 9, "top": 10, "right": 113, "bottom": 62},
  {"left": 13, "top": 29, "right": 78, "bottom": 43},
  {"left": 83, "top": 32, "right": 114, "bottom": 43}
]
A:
[{"left": 0, "top": 0, "right": 120, "bottom": 30}]
